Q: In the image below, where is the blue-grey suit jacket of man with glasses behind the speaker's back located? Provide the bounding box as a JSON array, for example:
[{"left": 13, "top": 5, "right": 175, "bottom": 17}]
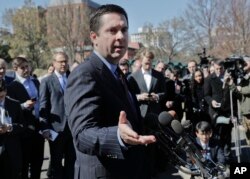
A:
[{"left": 40, "top": 73, "right": 66, "bottom": 132}]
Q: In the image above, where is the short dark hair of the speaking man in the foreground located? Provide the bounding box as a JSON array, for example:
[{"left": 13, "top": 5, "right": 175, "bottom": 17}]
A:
[{"left": 89, "top": 4, "right": 128, "bottom": 34}]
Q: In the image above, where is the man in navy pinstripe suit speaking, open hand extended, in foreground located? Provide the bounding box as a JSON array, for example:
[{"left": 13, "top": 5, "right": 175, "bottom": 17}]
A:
[{"left": 64, "top": 4, "right": 155, "bottom": 179}]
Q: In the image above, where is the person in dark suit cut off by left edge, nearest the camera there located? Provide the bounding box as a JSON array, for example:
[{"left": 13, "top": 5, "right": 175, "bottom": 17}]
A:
[{"left": 0, "top": 80, "right": 25, "bottom": 179}]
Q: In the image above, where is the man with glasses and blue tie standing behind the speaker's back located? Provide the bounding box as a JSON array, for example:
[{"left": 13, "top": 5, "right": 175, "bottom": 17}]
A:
[{"left": 40, "top": 52, "right": 75, "bottom": 179}]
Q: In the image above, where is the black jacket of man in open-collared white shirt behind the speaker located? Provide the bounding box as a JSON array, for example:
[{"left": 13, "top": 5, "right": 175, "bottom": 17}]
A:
[{"left": 129, "top": 69, "right": 166, "bottom": 117}]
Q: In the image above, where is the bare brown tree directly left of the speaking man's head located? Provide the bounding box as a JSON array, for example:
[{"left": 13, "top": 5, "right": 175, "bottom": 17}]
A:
[{"left": 47, "top": 0, "right": 90, "bottom": 64}]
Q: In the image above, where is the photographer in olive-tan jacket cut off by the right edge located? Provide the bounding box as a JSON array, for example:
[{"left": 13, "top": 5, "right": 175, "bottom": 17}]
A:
[{"left": 228, "top": 57, "right": 250, "bottom": 145}]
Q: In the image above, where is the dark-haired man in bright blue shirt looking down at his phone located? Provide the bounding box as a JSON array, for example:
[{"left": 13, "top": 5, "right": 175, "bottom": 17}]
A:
[{"left": 7, "top": 57, "right": 44, "bottom": 179}]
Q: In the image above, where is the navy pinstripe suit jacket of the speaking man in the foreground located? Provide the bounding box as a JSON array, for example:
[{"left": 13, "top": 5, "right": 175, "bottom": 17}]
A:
[{"left": 65, "top": 53, "right": 149, "bottom": 179}]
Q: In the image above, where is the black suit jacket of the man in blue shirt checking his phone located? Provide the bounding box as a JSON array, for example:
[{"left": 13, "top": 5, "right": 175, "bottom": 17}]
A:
[{"left": 7, "top": 79, "right": 40, "bottom": 132}]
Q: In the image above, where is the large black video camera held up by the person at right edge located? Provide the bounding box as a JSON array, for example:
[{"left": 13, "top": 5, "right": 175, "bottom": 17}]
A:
[{"left": 224, "top": 56, "right": 246, "bottom": 82}]
